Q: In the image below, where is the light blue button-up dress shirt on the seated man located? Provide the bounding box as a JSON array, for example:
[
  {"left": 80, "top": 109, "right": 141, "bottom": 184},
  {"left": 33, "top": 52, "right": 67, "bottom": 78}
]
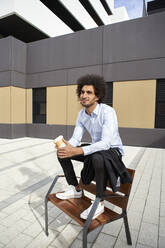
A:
[{"left": 69, "top": 103, "right": 124, "bottom": 155}]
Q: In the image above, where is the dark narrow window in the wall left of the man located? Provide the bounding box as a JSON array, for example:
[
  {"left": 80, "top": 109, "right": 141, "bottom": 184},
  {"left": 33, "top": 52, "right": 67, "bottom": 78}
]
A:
[{"left": 33, "top": 88, "right": 46, "bottom": 123}]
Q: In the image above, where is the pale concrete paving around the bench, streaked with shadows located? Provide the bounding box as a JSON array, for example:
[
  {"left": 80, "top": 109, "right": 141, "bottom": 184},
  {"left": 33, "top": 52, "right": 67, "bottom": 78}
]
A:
[{"left": 0, "top": 137, "right": 165, "bottom": 248}]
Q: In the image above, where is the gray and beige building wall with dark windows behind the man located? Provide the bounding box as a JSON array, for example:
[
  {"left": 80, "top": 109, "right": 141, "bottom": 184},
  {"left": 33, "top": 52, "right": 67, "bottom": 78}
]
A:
[{"left": 0, "top": 12, "right": 165, "bottom": 147}]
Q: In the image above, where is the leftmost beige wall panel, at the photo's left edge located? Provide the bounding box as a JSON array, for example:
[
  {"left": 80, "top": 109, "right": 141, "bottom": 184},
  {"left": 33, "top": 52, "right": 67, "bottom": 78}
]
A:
[{"left": 0, "top": 87, "right": 11, "bottom": 123}]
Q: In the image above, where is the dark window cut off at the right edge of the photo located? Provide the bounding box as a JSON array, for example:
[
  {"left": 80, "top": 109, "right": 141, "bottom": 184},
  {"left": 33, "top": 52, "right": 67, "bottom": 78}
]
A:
[{"left": 155, "top": 79, "right": 165, "bottom": 128}]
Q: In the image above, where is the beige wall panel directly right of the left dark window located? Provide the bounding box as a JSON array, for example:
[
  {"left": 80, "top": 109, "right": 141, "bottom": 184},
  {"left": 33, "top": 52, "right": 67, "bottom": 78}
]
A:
[{"left": 47, "top": 86, "right": 67, "bottom": 125}]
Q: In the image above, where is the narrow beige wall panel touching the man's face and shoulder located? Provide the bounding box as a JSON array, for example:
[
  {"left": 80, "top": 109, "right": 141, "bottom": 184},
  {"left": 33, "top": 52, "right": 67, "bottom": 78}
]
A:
[{"left": 67, "top": 85, "right": 82, "bottom": 125}]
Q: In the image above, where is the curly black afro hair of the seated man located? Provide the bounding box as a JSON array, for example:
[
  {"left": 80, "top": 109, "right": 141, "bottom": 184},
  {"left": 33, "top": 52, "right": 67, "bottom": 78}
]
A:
[{"left": 76, "top": 74, "right": 106, "bottom": 103}]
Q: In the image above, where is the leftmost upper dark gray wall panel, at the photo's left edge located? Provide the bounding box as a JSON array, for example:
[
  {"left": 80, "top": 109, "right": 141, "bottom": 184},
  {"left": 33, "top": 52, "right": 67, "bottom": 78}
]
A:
[{"left": 0, "top": 37, "right": 11, "bottom": 71}]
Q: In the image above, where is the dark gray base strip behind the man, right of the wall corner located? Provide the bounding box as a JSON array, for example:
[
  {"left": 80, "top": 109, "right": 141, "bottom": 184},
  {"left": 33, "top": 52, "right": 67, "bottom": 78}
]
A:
[{"left": 27, "top": 124, "right": 165, "bottom": 148}]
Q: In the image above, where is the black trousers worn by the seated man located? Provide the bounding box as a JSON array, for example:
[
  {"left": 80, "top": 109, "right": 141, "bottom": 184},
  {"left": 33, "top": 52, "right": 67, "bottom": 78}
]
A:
[{"left": 58, "top": 152, "right": 107, "bottom": 199}]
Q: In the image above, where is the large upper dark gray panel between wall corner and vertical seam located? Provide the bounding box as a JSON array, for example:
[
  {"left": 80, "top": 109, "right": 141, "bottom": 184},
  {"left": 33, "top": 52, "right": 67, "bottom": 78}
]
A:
[{"left": 27, "top": 28, "right": 102, "bottom": 73}]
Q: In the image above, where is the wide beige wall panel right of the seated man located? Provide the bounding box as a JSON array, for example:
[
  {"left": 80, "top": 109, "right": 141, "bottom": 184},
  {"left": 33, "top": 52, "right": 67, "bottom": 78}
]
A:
[{"left": 113, "top": 80, "right": 156, "bottom": 128}]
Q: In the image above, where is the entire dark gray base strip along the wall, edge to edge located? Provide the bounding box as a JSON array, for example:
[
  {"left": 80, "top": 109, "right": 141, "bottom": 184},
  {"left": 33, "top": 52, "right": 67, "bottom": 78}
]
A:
[{"left": 0, "top": 124, "right": 165, "bottom": 148}]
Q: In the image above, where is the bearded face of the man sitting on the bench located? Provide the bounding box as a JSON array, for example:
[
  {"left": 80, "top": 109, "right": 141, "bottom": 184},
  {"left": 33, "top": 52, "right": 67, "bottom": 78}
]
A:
[{"left": 80, "top": 85, "right": 99, "bottom": 108}]
